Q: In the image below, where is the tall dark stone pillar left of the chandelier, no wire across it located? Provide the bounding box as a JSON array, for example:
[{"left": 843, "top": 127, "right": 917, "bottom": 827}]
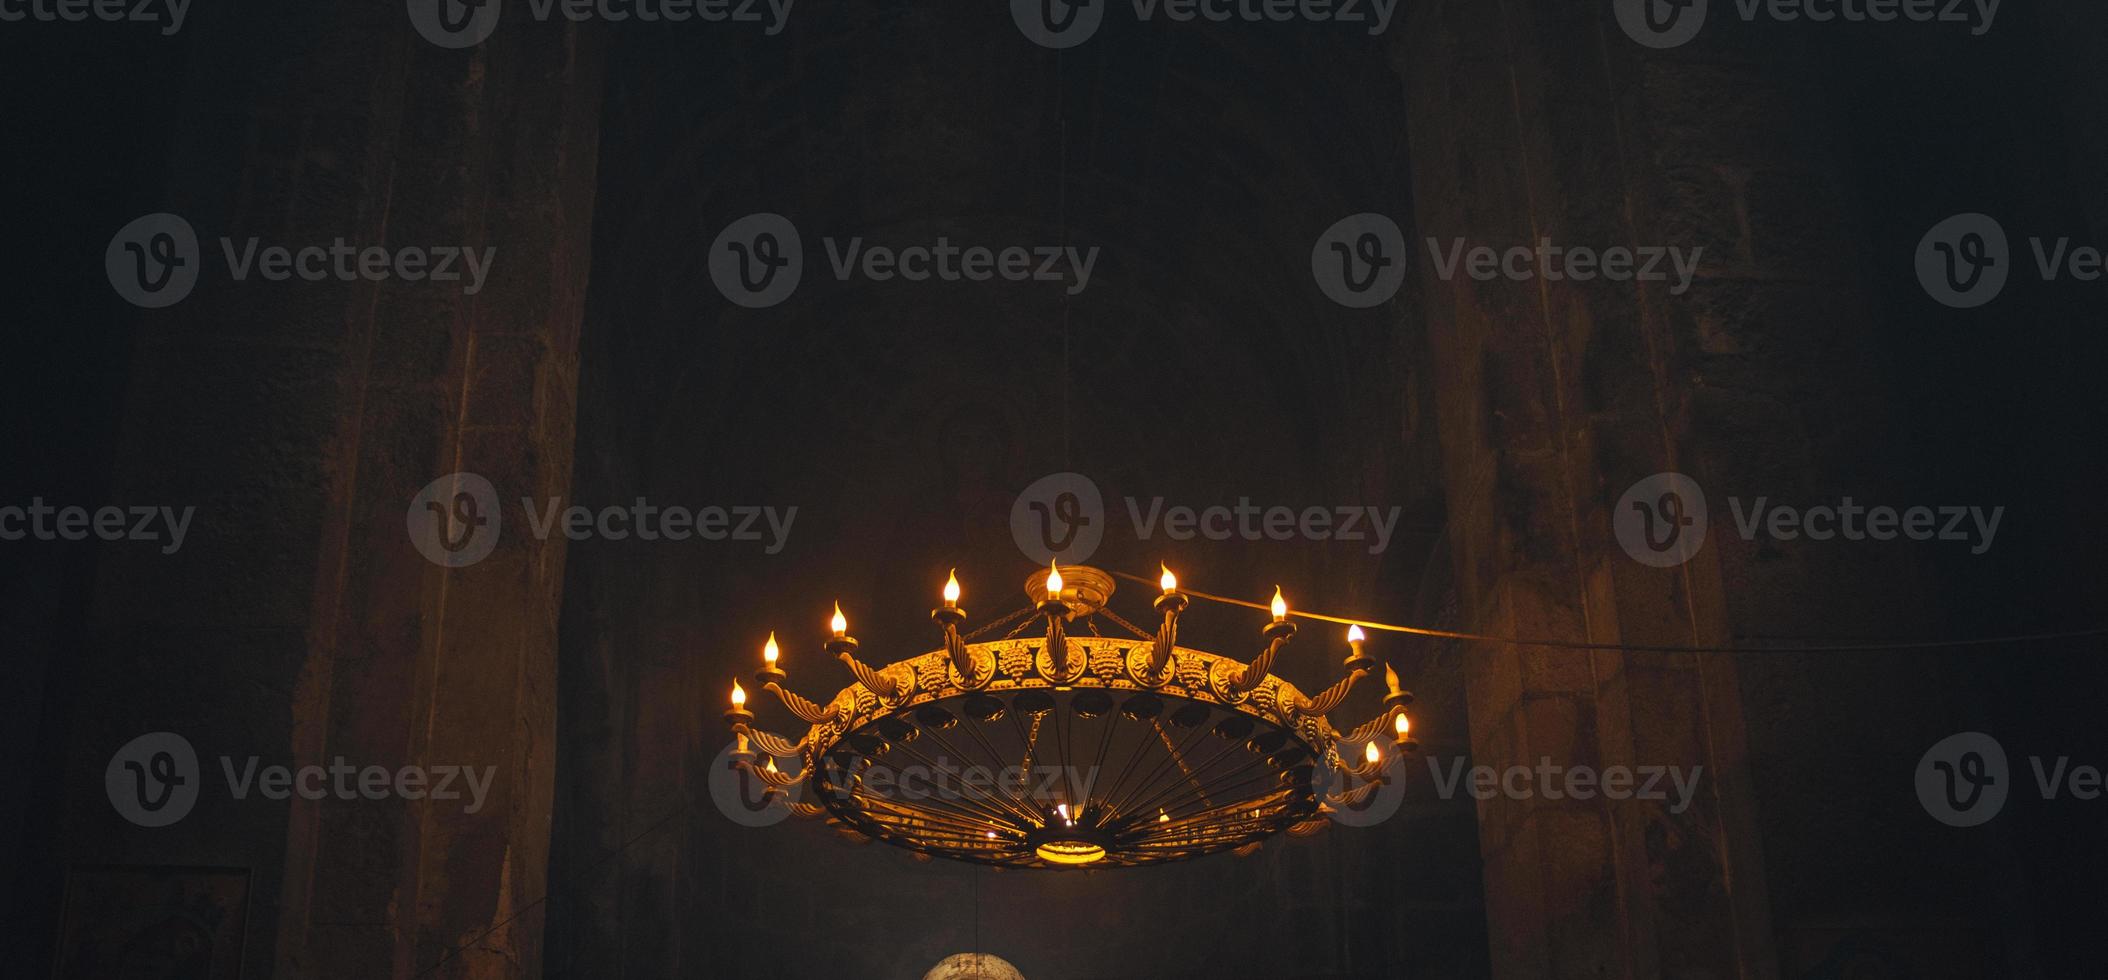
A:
[{"left": 65, "top": 4, "right": 601, "bottom": 978}]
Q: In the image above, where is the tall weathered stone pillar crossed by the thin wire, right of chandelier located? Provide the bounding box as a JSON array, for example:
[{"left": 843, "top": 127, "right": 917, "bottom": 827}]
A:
[{"left": 1398, "top": 0, "right": 1922, "bottom": 978}]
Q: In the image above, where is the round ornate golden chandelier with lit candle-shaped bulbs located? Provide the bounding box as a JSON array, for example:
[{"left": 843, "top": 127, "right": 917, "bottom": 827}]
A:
[{"left": 725, "top": 565, "right": 1419, "bottom": 868}]
